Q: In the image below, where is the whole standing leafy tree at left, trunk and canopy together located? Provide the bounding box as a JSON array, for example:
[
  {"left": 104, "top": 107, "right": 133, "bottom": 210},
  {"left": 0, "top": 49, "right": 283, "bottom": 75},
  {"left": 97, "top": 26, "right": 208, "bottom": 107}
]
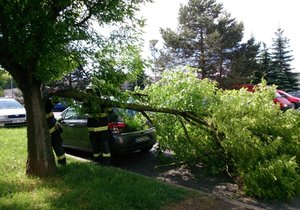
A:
[{"left": 0, "top": 0, "right": 148, "bottom": 176}]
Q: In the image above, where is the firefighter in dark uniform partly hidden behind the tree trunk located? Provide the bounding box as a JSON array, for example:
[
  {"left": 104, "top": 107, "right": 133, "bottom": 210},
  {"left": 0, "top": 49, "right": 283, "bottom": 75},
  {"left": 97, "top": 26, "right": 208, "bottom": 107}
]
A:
[{"left": 45, "top": 99, "right": 67, "bottom": 165}]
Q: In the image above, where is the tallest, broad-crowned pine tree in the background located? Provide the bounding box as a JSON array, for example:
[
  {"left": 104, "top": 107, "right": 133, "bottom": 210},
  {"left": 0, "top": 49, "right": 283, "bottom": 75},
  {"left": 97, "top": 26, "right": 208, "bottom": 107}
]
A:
[{"left": 161, "top": 0, "right": 243, "bottom": 81}]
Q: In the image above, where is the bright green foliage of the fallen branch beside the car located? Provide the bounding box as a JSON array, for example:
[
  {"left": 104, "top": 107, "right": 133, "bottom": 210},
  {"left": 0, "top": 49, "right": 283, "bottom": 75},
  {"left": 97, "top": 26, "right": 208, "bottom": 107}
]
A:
[{"left": 140, "top": 71, "right": 300, "bottom": 198}]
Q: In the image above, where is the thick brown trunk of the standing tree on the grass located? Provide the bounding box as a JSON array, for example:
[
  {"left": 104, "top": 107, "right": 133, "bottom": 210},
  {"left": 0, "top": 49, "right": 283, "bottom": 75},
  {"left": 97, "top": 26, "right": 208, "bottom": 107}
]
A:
[{"left": 20, "top": 81, "right": 57, "bottom": 177}]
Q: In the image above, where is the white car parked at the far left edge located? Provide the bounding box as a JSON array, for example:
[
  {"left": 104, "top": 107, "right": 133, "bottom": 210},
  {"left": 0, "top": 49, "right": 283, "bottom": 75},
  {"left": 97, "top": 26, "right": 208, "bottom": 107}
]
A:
[{"left": 0, "top": 98, "right": 26, "bottom": 127}]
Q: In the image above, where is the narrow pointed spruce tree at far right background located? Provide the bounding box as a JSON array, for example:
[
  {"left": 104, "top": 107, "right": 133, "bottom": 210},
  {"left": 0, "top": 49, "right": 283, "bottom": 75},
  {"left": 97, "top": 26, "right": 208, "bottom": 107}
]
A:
[{"left": 268, "top": 28, "right": 298, "bottom": 91}]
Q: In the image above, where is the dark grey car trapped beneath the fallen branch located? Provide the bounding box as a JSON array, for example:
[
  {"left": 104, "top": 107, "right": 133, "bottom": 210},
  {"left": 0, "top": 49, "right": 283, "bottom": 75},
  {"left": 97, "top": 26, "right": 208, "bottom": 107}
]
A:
[{"left": 58, "top": 108, "right": 156, "bottom": 155}]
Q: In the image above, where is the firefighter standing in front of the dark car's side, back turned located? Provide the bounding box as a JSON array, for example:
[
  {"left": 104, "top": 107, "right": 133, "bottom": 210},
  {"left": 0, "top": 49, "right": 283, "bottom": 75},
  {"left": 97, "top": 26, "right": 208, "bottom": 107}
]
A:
[{"left": 84, "top": 84, "right": 112, "bottom": 165}]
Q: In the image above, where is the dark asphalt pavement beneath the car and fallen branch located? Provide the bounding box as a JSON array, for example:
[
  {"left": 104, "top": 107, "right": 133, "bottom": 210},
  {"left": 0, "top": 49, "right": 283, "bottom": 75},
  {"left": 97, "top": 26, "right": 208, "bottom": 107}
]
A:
[{"left": 66, "top": 149, "right": 300, "bottom": 210}]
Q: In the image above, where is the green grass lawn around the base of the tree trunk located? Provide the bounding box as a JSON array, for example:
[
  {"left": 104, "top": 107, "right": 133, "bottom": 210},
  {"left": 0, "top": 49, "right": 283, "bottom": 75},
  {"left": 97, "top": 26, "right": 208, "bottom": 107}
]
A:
[{"left": 0, "top": 128, "right": 195, "bottom": 210}]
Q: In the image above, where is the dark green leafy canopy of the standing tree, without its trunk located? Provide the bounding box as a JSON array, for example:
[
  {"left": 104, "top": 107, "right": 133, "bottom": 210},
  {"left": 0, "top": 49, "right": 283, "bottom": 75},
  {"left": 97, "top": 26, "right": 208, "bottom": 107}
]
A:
[{"left": 0, "top": 0, "right": 147, "bottom": 82}]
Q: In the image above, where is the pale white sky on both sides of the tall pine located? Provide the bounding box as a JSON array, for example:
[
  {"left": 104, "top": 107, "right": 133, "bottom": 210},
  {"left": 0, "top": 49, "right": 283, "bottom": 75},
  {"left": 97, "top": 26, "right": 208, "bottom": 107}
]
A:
[{"left": 141, "top": 0, "right": 300, "bottom": 72}]
